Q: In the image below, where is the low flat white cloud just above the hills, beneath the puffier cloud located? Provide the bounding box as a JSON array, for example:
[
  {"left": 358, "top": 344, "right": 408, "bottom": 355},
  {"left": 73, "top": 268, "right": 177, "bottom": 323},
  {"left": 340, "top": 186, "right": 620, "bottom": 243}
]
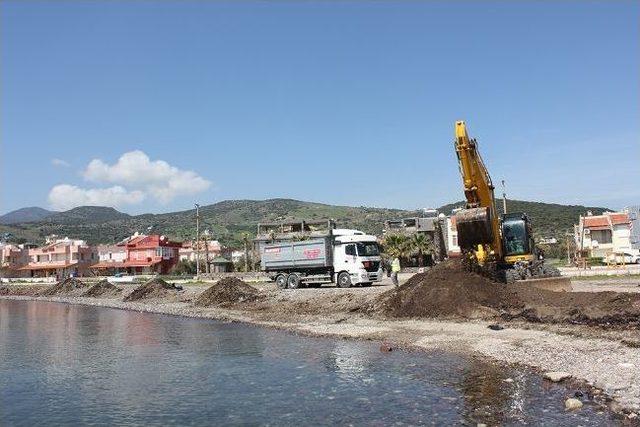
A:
[{"left": 49, "top": 184, "right": 145, "bottom": 210}]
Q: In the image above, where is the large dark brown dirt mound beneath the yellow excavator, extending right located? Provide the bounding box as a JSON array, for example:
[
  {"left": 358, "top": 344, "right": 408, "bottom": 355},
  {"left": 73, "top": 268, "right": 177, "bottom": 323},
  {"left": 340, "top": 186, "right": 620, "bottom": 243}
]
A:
[{"left": 368, "top": 260, "right": 640, "bottom": 328}]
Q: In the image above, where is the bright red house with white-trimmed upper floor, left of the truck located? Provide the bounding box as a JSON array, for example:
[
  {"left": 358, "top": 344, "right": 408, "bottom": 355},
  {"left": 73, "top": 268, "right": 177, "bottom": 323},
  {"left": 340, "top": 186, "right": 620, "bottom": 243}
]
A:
[{"left": 118, "top": 234, "right": 182, "bottom": 274}]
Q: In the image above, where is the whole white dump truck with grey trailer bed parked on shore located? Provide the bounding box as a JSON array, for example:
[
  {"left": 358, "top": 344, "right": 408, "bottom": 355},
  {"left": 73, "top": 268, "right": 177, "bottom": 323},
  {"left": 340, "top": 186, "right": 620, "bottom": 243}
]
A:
[{"left": 257, "top": 222, "right": 382, "bottom": 289}]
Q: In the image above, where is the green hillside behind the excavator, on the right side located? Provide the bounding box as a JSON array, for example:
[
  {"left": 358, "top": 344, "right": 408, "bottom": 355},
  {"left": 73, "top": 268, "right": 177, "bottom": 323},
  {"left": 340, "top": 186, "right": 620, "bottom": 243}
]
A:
[{"left": 438, "top": 199, "right": 611, "bottom": 238}]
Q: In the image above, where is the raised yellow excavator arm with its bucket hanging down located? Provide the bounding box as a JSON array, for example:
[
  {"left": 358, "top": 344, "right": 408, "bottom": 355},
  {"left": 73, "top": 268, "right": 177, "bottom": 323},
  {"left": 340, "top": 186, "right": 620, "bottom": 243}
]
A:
[{"left": 455, "top": 121, "right": 502, "bottom": 264}]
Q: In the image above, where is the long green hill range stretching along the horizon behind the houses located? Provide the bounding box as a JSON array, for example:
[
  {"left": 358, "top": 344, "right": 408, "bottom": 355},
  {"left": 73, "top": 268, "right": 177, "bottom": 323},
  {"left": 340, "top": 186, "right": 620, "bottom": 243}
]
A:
[{"left": 0, "top": 199, "right": 606, "bottom": 247}]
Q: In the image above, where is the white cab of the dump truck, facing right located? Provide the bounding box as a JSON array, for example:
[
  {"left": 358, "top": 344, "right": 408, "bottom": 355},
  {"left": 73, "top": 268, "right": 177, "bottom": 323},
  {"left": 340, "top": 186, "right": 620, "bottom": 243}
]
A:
[{"left": 333, "top": 229, "right": 381, "bottom": 288}]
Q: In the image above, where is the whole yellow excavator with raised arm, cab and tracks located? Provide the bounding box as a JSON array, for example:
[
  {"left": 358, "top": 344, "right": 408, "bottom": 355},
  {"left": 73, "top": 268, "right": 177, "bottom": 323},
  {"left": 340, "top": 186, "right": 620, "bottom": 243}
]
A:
[{"left": 455, "top": 121, "right": 571, "bottom": 291}]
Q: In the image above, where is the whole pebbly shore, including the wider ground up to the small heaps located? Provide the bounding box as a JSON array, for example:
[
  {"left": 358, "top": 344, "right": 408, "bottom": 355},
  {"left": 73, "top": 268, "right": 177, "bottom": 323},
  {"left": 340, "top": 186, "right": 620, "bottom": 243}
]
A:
[{"left": 0, "top": 274, "right": 640, "bottom": 424}]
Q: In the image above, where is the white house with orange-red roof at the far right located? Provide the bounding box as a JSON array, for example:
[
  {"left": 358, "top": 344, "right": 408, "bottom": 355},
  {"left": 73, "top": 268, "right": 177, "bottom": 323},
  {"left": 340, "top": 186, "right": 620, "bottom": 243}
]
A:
[{"left": 574, "top": 212, "right": 631, "bottom": 258}]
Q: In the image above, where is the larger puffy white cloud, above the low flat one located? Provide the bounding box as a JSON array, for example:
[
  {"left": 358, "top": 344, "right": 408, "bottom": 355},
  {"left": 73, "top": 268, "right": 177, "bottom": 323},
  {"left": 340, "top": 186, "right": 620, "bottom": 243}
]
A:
[{"left": 83, "top": 150, "right": 211, "bottom": 203}]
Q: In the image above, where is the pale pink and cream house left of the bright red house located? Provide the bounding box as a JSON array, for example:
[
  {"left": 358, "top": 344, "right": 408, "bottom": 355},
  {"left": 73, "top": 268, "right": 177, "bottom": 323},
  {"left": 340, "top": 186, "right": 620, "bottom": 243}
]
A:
[{"left": 18, "top": 236, "right": 98, "bottom": 278}]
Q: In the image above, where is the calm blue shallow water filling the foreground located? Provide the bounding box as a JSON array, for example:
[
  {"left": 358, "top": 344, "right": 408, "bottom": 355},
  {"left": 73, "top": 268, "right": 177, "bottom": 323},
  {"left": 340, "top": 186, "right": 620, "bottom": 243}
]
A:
[{"left": 0, "top": 299, "right": 615, "bottom": 426}]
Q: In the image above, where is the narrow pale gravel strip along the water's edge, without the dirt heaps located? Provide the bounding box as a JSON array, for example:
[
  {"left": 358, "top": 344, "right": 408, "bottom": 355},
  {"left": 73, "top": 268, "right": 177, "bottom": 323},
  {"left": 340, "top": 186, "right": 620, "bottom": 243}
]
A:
[{"left": 0, "top": 295, "right": 640, "bottom": 422}]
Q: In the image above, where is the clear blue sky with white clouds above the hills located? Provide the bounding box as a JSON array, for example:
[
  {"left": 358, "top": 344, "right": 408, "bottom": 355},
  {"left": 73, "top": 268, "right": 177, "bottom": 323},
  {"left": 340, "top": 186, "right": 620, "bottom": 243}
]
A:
[{"left": 0, "top": 0, "right": 640, "bottom": 213}]
